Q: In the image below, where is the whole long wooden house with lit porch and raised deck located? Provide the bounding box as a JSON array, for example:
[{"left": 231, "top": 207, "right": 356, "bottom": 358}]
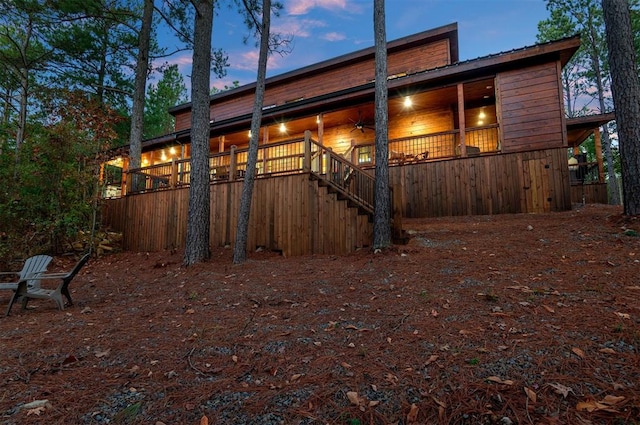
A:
[{"left": 103, "top": 24, "right": 613, "bottom": 255}]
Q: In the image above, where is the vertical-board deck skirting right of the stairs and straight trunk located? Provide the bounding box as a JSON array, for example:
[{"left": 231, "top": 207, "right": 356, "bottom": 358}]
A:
[{"left": 389, "top": 149, "right": 571, "bottom": 218}]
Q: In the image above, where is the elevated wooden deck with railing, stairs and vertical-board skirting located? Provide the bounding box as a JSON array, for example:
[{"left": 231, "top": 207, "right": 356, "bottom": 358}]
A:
[{"left": 102, "top": 128, "right": 606, "bottom": 255}]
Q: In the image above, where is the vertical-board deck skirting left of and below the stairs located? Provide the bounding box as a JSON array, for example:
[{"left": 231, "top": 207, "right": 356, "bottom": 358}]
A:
[{"left": 102, "top": 174, "right": 372, "bottom": 255}]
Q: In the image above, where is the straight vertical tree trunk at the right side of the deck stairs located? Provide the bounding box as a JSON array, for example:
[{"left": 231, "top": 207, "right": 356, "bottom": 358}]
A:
[{"left": 373, "top": 0, "right": 391, "bottom": 249}]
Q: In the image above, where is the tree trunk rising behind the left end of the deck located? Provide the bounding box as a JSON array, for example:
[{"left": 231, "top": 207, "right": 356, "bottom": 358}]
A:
[{"left": 129, "top": 0, "right": 153, "bottom": 171}]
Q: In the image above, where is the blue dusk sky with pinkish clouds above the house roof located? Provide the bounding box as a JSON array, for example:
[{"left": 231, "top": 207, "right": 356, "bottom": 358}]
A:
[{"left": 159, "top": 0, "right": 549, "bottom": 92}]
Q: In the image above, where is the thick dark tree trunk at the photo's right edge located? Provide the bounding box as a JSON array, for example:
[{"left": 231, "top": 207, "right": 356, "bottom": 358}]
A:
[{"left": 602, "top": 0, "right": 640, "bottom": 215}]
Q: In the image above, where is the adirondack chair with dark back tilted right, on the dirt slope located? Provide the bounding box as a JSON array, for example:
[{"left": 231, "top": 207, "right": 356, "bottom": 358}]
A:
[{"left": 6, "top": 254, "right": 90, "bottom": 316}]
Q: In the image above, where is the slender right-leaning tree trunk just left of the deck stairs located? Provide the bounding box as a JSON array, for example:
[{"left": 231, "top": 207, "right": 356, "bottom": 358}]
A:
[{"left": 233, "top": 0, "right": 271, "bottom": 264}]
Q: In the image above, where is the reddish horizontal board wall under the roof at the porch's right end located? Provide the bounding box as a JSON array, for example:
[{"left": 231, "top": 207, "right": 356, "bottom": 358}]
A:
[{"left": 496, "top": 62, "right": 567, "bottom": 152}]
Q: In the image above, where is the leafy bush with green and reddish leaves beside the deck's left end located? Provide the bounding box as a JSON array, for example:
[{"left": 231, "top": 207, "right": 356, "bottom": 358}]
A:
[{"left": 0, "top": 93, "right": 117, "bottom": 260}]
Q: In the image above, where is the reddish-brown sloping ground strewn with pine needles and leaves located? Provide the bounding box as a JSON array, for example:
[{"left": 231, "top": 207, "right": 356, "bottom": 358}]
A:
[{"left": 0, "top": 206, "right": 640, "bottom": 425}]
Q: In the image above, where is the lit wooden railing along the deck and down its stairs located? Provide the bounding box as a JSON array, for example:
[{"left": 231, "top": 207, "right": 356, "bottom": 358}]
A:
[{"left": 126, "top": 125, "right": 500, "bottom": 195}]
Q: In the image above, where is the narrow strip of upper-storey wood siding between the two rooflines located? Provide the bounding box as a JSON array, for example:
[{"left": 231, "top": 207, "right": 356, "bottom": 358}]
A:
[{"left": 170, "top": 39, "right": 451, "bottom": 131}]
